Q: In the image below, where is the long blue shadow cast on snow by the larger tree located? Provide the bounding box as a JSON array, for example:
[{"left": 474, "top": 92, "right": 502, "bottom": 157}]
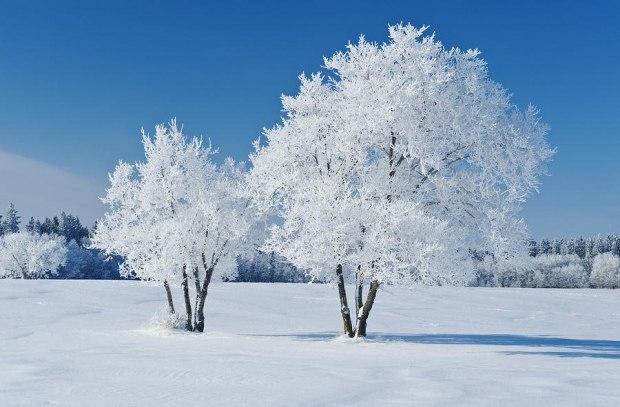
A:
[{"left": 247, "top": 332, "right": 620, "bottom": 359}]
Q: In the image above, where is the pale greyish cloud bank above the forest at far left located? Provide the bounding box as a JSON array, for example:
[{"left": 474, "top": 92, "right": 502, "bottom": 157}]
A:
[{"left": 0, "top": 150, "right": 105, "bottom": 225}]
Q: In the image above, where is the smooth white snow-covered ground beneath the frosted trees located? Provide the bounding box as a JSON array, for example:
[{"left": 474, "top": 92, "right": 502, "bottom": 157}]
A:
[{"left": 0, "top": 280, "right": 620, "bottom": 406}]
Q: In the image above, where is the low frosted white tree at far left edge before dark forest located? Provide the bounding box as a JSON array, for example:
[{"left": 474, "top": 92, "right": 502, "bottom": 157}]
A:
[{"left": 0, "top": 233, "right": 67, "bottom": 279}]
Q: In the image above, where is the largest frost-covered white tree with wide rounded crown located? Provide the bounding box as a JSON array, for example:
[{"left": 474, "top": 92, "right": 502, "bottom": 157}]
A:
[{"left": 250, "top": 25, "right": 552, "bottom": 336}]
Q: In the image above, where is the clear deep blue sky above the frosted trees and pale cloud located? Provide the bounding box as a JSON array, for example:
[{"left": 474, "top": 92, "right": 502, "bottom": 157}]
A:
[{"left": 0, "top": 0, "right": 620, "bottom": 237}]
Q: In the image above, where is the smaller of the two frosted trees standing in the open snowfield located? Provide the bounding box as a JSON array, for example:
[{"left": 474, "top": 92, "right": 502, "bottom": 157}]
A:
[{"left": 92, "top": 120, "right": 252, "bottom": 331}]
